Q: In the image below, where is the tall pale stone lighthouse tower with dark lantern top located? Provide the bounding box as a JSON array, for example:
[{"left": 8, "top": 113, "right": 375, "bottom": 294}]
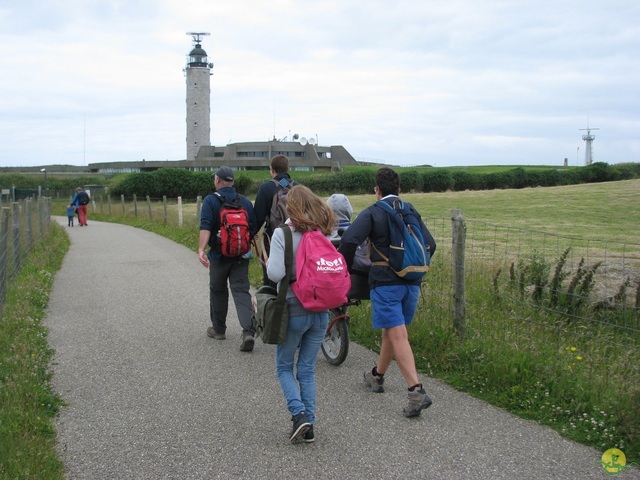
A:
[{"left": 184, "top": 32, "right": 213, "bottom": 160}]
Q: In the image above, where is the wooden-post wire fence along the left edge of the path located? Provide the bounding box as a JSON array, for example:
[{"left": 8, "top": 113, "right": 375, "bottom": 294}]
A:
[{"left": 0, "top": 197, "right": 51, "bottom": 313}]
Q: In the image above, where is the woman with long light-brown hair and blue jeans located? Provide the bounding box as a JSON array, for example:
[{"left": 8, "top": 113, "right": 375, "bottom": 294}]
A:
[{"left": 267, "top": 185, "right": 336, "bottom": 443}]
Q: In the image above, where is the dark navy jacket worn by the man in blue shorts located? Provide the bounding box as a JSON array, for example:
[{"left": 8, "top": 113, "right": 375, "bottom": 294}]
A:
[{"left": 338, "top": 196, "right": 436, "bottom": 288}]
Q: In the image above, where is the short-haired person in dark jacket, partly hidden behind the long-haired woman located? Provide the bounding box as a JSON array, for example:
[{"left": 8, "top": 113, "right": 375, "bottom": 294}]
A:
[{"left": 253, "top": 154, "right": 298, "bottom": 287}]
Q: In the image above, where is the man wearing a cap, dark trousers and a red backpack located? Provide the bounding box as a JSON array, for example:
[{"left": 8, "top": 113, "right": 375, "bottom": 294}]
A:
[{"left": 198, "top": 167, "right": 257, "bottom": 352}]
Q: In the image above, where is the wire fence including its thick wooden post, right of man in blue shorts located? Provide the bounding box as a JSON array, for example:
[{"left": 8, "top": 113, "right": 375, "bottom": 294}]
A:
[{"left": 426, "top": 213, "right": 640, "bottom": 349}]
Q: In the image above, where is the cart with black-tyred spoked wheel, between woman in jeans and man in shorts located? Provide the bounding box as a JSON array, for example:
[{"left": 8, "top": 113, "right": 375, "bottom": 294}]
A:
[{"left": 321, "top": 275, "right": 369, "bottom": 365}]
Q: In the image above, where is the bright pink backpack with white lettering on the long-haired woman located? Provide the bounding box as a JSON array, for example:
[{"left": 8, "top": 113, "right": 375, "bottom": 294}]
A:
[{"left": 291, "top": 230, "right": 351, "bottom": 312}]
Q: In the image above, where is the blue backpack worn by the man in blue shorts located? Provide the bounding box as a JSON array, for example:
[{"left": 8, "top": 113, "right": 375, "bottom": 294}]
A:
[{"left": 371, "top": 199, "right": 431, "bottom": 280}]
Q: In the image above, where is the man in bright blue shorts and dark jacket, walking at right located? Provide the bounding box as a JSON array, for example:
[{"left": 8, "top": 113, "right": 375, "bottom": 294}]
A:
[{"left": 339, "top": 167, "right": 436, "bottom": 417}]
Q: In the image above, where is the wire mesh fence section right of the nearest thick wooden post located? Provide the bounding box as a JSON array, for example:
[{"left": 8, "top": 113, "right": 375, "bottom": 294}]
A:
[{"left": 465, "top": 221, "right": 640, "bottom": 348}]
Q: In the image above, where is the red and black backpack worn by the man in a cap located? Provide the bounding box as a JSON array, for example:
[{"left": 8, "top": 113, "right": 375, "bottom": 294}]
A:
[{"left": 215, "top": 192, "right": 251, "bottom": 257}]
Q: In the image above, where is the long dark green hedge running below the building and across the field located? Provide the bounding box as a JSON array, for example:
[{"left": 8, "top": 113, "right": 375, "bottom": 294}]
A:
[{"left": 102, "top": 163, "right": 640, "bottom": 198}]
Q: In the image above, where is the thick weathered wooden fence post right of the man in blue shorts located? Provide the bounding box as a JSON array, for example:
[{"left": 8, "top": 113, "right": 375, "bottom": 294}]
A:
[{"left": 451, "top": 210, "right": 467, "bottom": 337}]
